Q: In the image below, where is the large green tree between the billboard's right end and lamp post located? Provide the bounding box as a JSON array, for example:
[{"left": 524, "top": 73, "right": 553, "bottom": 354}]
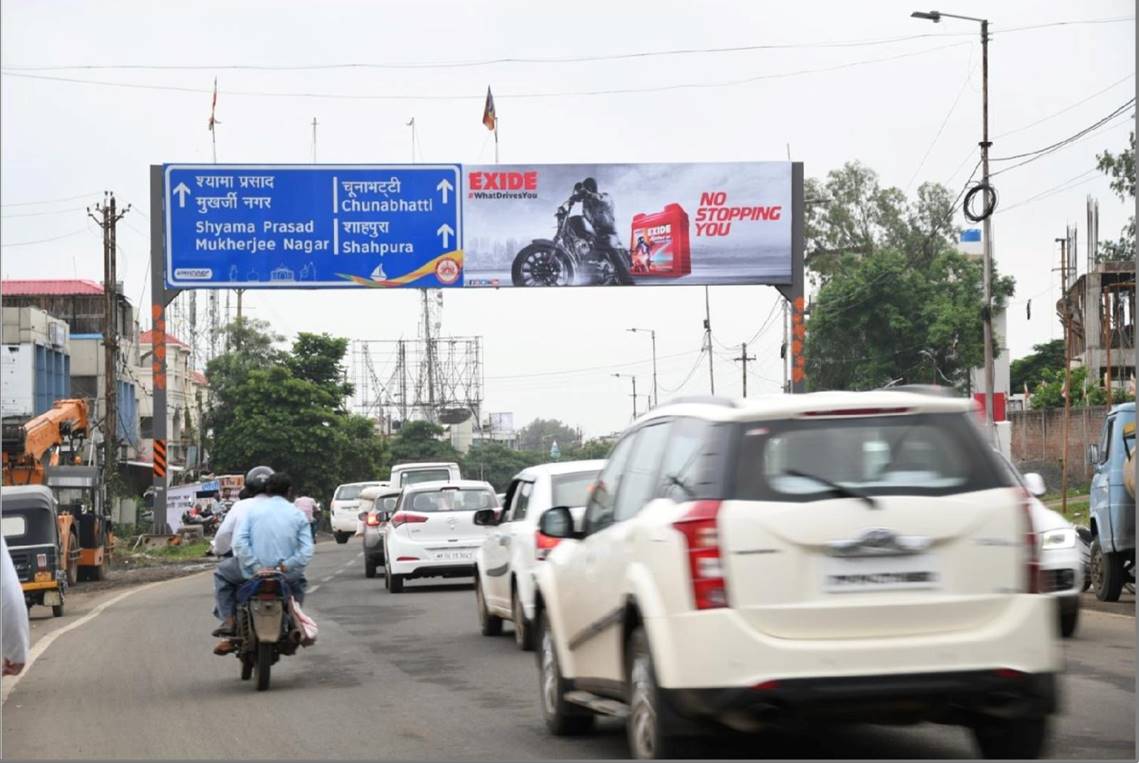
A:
[{"left": 805, "top": 163, "right": 1014, "bottom": 389}]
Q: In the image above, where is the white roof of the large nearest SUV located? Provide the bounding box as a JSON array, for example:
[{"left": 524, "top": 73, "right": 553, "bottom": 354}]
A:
[{"left": 639, "top": 389, "right": 976, "bottom": 421}]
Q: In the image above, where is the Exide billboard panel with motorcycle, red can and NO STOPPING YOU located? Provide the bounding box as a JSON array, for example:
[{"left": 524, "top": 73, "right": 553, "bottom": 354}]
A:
[{"left": 462, "top": 162, "right": 795, "bottom": 287}]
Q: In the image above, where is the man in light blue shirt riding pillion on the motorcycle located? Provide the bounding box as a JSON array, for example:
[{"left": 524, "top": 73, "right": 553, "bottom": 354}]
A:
[{"left": 233, "top": 471, "right": 313, "bottom": 604}]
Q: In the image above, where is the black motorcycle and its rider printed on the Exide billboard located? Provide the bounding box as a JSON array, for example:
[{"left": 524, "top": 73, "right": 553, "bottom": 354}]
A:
[{"left": 510, "top": 194, "right": 633, "bottom": 286}]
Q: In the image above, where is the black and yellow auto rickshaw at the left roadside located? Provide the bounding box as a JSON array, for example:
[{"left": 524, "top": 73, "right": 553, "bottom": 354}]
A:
[{"left": 0, "top": 485, "right": 71, "bottom": 617}]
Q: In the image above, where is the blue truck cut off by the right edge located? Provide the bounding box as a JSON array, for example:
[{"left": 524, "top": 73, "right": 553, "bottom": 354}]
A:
[{"left": 1088, "top": 403, "right": 1136, "bottom": 601}]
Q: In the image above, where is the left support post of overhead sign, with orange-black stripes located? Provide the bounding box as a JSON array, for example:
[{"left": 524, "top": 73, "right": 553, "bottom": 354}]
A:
[{"left": 150, "top": 164, "right": 180, "bottom": 535}]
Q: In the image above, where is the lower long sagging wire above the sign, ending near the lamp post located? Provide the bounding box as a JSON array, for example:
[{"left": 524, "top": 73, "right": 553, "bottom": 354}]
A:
[{"left": 0, "top": 42, "right": 972, "bottom": 101}]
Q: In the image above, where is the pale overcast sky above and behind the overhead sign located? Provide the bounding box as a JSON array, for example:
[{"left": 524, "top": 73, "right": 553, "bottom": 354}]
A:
[{"left": 0, "top": 0, "right": 1136, "bottom": 435}]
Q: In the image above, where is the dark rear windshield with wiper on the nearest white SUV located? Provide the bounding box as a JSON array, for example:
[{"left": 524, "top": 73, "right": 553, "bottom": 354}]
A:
[{"left": 735, "top": 413, "right": 1016, "bottom": 501}]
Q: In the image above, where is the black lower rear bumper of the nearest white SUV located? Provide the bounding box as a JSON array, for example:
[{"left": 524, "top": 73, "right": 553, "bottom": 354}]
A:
[{"left": 662, "top": 670, "right": 1058, "bottom": 724}]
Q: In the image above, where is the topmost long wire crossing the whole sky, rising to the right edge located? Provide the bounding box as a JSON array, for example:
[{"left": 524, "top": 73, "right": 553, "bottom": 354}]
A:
[{"left": 7, "top": 16, "right": 1134, "bottom": 72}]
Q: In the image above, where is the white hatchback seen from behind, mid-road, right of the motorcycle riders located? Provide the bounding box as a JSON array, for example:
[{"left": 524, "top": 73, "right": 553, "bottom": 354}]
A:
[{"left": 384, "top": 479, "right": 499, "bottom": 593}]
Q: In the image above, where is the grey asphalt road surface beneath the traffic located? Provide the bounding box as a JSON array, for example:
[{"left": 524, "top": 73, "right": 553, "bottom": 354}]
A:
[{"left": 2, "top": 540, "right": 1136, "bottom": 761}]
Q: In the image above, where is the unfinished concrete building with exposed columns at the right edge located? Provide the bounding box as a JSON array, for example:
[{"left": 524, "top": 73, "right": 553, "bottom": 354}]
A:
[{"left": 1056, "top": 261, "right": 1136, "bottom": 392}]
